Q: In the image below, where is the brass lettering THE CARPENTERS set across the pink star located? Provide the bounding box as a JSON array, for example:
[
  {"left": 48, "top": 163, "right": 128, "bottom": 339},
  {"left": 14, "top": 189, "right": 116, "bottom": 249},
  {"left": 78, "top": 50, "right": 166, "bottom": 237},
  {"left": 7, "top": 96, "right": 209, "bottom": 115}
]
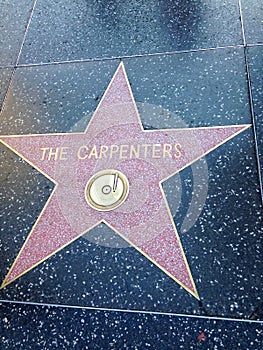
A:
[{"left": 40, "top": 143, "right": 183, "bottom": 161}]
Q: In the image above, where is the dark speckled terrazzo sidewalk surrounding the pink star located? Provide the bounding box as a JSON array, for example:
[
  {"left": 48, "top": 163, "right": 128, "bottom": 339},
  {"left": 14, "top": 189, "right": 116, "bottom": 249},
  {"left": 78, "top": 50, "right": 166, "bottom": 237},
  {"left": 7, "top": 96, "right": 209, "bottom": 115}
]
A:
[{"left": 0, "top": 0, "right": 263, "bottom": 350}]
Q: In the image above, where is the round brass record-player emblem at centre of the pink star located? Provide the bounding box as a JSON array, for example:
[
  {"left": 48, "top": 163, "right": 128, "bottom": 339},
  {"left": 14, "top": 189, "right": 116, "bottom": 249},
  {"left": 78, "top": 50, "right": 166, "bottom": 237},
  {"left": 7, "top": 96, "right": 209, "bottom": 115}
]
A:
[{"left": 85, "top": 169, "right": 129, "bottom": 211}]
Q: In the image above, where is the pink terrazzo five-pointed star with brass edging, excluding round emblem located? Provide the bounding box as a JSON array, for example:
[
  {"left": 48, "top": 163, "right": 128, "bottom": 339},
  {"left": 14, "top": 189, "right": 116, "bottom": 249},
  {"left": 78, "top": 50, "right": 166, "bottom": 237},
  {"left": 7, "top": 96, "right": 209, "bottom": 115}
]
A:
[{"left": 0, "top": 63, "right": 251, "bottom": 298}]
